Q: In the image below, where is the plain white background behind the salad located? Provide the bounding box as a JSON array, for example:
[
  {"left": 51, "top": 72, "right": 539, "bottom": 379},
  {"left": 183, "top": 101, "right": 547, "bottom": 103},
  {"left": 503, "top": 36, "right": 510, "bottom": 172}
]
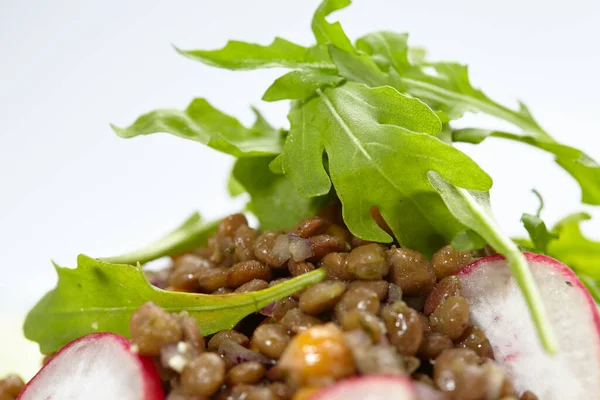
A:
[{"left": 0, "top": 0, "right": 600, "bottom": 372}]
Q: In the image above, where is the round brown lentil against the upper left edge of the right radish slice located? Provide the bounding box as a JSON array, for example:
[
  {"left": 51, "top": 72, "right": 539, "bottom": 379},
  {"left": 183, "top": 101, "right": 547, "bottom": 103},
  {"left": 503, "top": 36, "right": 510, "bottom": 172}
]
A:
[{"left": 429, "top": 296, "right": 469, "bottom": 340}]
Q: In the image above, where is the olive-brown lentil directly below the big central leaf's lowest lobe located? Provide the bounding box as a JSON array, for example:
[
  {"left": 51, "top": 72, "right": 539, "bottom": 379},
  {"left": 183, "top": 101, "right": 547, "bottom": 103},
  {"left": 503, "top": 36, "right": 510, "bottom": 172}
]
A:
[{"left": 346, "top": 243, "right": 390, "bottom": 280}]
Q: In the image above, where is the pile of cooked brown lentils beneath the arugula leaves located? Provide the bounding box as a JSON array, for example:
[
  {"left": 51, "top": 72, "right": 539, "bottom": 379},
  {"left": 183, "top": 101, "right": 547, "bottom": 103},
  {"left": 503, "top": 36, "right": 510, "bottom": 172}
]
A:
[{"left": 0, "top": 209, "right": 537, "bottom": 400}]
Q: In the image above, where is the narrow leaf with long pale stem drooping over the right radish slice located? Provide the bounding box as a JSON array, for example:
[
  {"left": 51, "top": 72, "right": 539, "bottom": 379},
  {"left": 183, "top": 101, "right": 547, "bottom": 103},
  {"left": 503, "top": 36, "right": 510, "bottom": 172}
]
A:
[{"left": 428, "top": 171, "right": 558, "bottom": 353}]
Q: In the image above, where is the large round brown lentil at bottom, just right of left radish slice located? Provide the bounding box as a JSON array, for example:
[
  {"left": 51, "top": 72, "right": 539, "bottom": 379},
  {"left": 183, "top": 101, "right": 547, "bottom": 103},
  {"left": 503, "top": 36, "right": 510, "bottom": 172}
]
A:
[{"left": 181, "top": 353, "right": 225, "bottom": 396}]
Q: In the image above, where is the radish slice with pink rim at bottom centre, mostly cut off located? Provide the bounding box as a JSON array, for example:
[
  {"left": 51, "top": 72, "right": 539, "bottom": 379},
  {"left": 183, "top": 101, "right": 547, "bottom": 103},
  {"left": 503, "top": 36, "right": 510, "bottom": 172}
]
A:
[{"left": 311, "top": 375, "right": 418, "bottom": 400}]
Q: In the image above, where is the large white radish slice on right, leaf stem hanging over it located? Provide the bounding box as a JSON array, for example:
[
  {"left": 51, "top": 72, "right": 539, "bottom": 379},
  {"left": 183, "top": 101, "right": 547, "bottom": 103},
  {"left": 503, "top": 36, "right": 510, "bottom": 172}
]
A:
[{"left": 458, "top": 253, "right": 600, "bottom": 400}]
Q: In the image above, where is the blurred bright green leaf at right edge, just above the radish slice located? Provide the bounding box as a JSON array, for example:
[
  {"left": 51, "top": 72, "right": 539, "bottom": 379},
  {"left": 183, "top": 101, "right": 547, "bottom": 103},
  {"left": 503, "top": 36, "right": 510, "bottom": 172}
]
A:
[{"left": 548, "top": 213, "right": 600, "bottom": 280}]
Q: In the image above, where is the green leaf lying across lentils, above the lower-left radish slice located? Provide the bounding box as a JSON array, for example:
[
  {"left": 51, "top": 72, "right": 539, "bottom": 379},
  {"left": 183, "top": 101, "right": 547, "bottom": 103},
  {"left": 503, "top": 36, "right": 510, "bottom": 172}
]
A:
[{"left": 23, "top": 255, "right": 325, "bottom": 354}]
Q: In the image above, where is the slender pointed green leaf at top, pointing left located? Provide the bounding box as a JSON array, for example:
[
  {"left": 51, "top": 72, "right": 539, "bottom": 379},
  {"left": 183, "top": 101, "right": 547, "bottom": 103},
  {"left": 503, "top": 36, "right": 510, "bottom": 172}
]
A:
[{"left": 176, "top": 38, "right": 334, "bottom": 70}]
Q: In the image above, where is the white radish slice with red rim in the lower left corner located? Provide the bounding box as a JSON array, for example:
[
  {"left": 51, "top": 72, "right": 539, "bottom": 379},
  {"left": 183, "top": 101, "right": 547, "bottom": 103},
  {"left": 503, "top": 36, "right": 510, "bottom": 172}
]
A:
[{"left": 18, "top": 333, "right": 165, "bottom": 400}]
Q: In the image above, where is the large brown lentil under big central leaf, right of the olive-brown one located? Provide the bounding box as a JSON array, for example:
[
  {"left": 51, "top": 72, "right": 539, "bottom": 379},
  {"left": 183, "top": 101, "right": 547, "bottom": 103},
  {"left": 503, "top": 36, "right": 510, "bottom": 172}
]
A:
[{"left": 387, "top": 248, "right": 435, "bottom": 296}]
